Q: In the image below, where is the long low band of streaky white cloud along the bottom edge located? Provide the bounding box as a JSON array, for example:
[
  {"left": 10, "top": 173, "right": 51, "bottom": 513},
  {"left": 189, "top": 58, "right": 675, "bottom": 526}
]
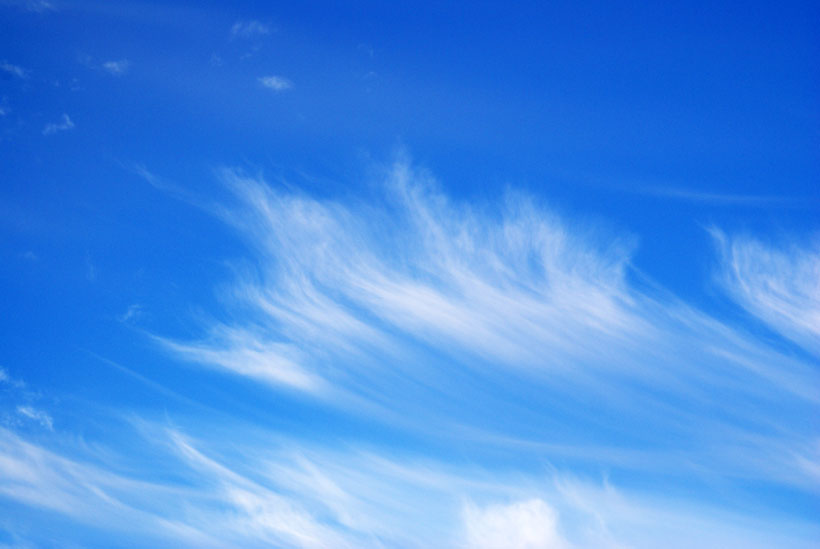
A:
[{"left": 0, "top": 425, "right": 820, "bottom": 549}]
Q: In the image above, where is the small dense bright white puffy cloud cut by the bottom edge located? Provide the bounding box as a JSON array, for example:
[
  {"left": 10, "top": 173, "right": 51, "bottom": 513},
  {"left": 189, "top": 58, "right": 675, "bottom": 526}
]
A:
[{"left": 463, "top": 498, "right": 568, "bottom": 549}]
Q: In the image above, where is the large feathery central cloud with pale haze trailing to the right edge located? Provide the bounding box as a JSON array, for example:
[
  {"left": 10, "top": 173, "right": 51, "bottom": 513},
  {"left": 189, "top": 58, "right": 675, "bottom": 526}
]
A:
[{"left": 143, "top": 156, "right": 820, "bottom": 498}]
